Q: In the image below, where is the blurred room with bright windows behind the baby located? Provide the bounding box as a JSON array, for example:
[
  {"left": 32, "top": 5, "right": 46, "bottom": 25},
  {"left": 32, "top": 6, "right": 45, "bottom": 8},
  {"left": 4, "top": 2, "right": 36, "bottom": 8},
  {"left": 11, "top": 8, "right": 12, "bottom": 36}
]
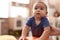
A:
[{"left": 0, "top": 0, "right": 60, "bottom": 40}]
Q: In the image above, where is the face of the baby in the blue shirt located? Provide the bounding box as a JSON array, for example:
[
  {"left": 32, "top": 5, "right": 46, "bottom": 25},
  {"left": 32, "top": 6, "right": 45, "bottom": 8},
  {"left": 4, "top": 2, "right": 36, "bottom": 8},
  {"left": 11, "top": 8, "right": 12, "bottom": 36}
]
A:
[{"left": 34, "top": 3, "right": 47, "bottom": 18}]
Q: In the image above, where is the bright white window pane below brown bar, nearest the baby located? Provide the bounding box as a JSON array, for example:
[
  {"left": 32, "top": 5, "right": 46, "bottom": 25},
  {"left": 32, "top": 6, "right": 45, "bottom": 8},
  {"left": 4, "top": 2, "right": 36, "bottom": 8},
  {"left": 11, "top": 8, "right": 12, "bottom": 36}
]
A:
[{"left": 11, "top": 6, "right": 29, "bottom": 18}]
